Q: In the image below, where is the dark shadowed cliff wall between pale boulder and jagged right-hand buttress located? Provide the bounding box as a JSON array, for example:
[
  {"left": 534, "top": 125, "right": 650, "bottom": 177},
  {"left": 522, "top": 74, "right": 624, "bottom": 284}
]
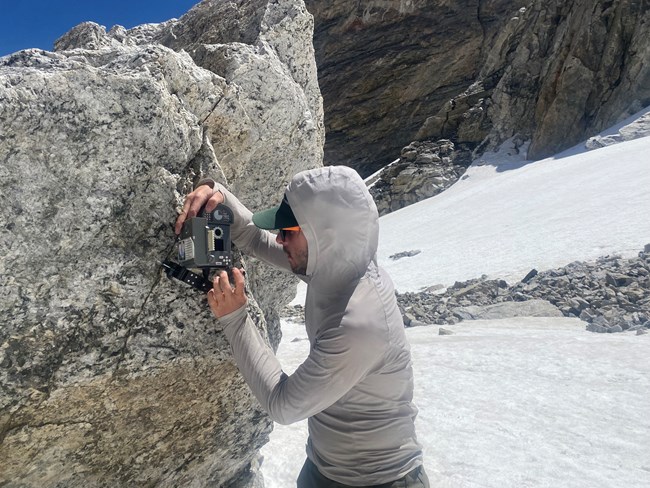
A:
[{"left": 306, "top": 0, "right": 527, "bottom": 176}]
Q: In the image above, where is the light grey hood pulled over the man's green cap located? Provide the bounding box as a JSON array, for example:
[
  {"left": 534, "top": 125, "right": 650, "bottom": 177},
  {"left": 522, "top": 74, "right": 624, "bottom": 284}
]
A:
[{"left": 285, "top": 166, "right": 379, "bottom": 293}]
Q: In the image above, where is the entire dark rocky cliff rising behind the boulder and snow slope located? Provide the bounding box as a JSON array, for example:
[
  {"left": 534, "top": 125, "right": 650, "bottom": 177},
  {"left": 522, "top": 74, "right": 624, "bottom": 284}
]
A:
[{"left": 307, "top": 0, "right": 650, "bottom": 175}]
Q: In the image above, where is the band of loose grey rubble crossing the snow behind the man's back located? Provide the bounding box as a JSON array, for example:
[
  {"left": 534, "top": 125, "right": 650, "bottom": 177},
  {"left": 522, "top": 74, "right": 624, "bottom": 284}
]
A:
[{"left": 390, "top": 250, "right": 650, "bottom": 332}]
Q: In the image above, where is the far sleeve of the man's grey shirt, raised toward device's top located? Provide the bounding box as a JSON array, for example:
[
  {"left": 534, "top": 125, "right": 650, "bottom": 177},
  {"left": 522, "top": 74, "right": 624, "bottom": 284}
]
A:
[{"left": 197, "top": 179, "right": 291, "bottom": 271}]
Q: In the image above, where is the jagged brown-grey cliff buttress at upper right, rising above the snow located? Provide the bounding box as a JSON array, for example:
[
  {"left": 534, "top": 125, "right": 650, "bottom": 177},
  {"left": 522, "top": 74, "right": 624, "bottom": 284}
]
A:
[{"left": 459, "top": 0, "right": 650, "bottom": 159}]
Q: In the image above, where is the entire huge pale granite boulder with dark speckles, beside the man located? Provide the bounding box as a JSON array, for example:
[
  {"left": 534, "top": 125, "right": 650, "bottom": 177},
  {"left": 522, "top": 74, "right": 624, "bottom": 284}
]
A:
[{"left": 0, "top": 2, "right": 322, "bottom": 487}]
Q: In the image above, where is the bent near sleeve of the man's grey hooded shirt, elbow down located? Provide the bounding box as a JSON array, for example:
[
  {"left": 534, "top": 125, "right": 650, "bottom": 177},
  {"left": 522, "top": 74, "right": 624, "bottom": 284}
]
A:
[{"left": 219, "top": 307, "right": 383, "bottom": 425}]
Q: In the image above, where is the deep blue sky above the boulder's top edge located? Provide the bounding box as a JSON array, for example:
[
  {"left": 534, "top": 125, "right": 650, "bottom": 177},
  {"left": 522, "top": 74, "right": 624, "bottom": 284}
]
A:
[{"left": 0, "top": 0, "right": 199, "bottom": 56}]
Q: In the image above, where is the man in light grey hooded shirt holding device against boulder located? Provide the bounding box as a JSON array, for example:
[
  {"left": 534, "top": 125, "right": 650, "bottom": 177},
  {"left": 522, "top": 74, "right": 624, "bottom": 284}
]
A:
[{"left": 176, "top": 166, "right": 429, "bottom": 488}]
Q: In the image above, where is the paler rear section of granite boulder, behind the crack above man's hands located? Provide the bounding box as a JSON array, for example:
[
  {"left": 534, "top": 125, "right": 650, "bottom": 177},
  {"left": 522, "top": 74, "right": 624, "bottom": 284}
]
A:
[{"left": 56, "top": 0, "right": 325, "bottom": 209}]
